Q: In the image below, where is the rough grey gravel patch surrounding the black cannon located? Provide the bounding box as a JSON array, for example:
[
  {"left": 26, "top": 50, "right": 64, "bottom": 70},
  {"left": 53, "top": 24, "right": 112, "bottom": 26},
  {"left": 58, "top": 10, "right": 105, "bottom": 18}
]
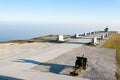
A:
[{"left": 32, "top": 46, "right": 116, "bottom": 80}]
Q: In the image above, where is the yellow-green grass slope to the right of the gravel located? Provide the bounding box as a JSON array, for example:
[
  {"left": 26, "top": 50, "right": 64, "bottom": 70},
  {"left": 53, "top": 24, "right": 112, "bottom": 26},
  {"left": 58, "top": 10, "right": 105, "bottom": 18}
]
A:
[{"left": 103, "top": 34, "right": 120, "bottom": 80}]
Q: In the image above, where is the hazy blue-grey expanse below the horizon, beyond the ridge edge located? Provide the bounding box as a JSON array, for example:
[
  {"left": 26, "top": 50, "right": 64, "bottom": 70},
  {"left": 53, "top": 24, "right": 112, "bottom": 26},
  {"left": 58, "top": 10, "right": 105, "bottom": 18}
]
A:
[{"left": 0, "top": 25, "right": 103, "bottom": 41}]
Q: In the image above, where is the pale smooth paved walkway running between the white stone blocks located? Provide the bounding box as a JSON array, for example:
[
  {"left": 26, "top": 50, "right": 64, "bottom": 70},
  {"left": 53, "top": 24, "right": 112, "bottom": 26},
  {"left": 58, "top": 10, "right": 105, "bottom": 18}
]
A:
[{"left": 0, "top": 34, "right": 109, "bottom": 80}]
